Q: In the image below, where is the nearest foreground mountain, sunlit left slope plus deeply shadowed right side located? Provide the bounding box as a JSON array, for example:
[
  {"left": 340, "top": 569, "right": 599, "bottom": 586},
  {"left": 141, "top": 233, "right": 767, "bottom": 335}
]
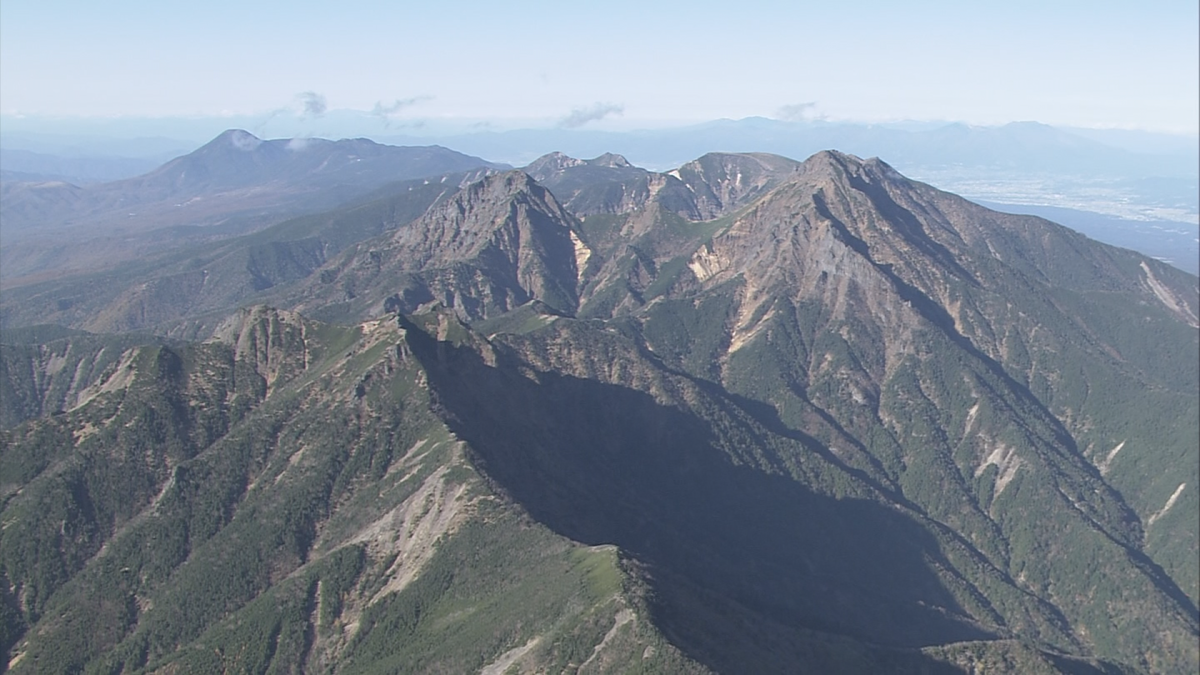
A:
[{"left": 0, "top": 307, "right": 1123, "bottom": 673}]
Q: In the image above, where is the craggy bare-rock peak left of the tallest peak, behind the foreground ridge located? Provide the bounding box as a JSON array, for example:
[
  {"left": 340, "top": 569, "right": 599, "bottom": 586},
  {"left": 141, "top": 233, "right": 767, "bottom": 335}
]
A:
[{"left": 301, "top": 172, "right": 586, "bottom": 319}]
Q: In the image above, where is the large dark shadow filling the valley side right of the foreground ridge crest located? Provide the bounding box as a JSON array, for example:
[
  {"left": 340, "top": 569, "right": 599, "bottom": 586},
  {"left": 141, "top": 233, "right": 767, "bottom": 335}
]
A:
[{"left": 408, "top": 317, "right": 995, "bottom": 673}]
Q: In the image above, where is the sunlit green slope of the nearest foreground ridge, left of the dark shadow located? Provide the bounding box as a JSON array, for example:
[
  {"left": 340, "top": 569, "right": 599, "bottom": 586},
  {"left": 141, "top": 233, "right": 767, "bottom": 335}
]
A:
[{"left": 0, "top": 307, "right": 703, "bottom": 673}]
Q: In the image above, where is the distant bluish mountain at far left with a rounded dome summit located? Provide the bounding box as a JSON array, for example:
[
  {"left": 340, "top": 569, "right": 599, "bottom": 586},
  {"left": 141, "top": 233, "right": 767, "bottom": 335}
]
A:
[{"left": 0, "top": 130, "right": 496, "bottom": 285}]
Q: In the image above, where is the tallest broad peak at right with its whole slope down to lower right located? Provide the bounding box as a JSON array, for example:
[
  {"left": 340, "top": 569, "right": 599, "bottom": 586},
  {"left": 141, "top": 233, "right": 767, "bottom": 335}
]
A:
[{"left": 549, "top": 151, "right": 1200, "bottom": 670}]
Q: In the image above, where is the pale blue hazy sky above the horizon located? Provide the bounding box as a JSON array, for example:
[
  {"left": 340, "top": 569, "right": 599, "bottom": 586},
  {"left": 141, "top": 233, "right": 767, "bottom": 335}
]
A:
[{"left": 0, "top": 0, "right": 1200, "bottom": 133}]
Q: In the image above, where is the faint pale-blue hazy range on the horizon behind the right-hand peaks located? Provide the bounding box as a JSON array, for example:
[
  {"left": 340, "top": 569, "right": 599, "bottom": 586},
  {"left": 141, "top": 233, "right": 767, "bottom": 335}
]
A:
[{"left": 379, "top": 118, "right": 1200, "bottom": 178}]
